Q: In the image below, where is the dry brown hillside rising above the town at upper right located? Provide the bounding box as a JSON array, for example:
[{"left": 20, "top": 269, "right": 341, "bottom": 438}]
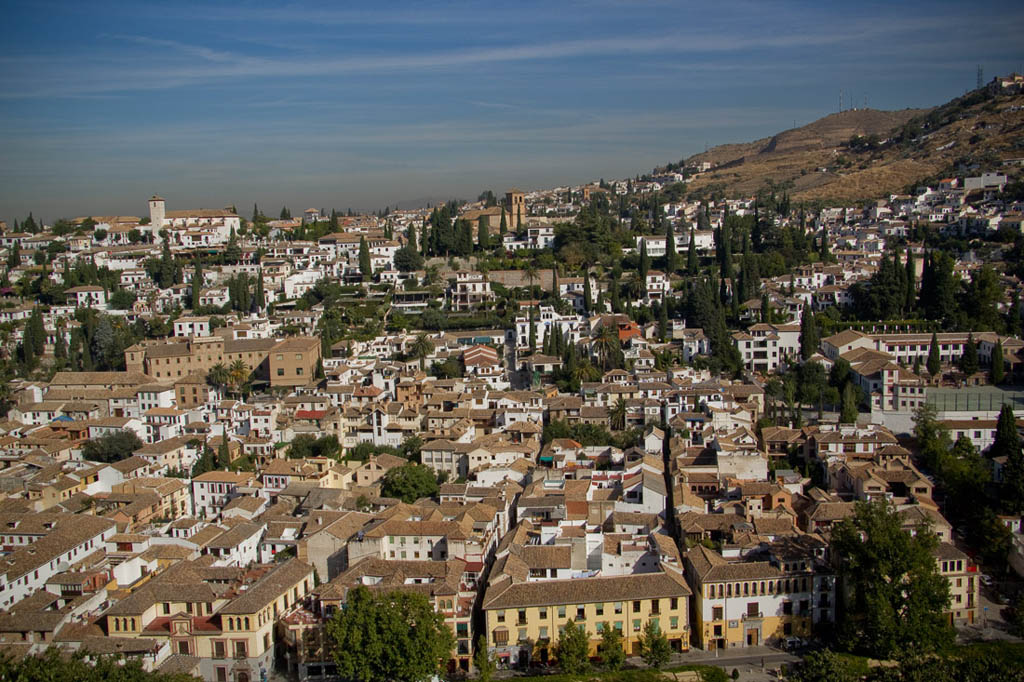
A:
[{"left": 685, "top": 90, "right": 1024, "bottom": 202}]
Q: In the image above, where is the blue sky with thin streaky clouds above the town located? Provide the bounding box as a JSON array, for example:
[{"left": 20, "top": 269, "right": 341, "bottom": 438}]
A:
[{"left": 0, "top": 0, "right": 1024, "bottom": 222}]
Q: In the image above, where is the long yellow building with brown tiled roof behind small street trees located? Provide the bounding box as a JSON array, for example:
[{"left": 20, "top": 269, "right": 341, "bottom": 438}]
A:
[{"left": 482, "top": 570, "right": 690, "bottom": 667}]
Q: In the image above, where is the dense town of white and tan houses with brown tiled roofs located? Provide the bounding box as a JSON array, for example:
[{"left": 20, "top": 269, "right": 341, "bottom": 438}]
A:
[{"left": 0, "top": 164, "right": 1024, "bottom": 682}]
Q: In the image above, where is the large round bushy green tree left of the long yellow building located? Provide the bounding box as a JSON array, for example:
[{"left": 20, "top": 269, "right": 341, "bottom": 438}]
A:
[{"left": 327, "top": 585, "right": 454, "bottom": 682}]
